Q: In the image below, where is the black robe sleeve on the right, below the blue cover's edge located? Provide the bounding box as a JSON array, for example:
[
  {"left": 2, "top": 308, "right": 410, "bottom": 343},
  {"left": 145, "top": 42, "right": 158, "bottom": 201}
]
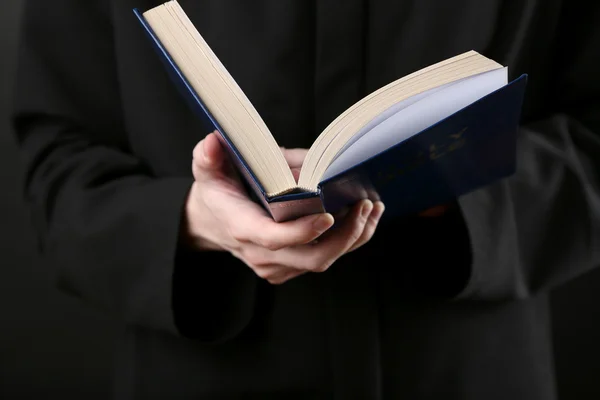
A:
[{"left": 458, "top": 1, "right": 600, "bottom": 300}]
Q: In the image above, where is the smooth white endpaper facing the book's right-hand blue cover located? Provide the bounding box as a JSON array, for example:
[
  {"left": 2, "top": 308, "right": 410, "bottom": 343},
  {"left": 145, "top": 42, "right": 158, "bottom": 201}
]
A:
[{"left": 321, "top": 67, "right": 508, "bottom": 180}]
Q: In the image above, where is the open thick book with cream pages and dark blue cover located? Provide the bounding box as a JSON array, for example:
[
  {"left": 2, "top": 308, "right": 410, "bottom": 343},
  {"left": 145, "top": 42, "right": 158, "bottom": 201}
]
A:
[{"left": 133, "top": 0, "right": 527, "bottom": 221}]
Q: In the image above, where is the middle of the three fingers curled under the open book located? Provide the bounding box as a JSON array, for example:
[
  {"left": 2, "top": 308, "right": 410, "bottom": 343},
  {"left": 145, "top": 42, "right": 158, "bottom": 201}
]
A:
[{"left": 271, "top": 200, "right": 373, "bottom": 272}]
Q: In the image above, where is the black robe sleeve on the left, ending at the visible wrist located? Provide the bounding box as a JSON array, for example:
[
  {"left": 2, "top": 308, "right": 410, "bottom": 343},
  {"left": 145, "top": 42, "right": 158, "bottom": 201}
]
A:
[{"left": 12, "top": 0, "right": 257, "bottom": 342}]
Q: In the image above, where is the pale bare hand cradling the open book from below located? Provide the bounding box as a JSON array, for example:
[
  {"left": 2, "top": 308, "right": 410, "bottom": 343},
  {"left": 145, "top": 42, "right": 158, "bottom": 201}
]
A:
[{"left": 184, "top": 133, "right": 384, "bottom": 284}]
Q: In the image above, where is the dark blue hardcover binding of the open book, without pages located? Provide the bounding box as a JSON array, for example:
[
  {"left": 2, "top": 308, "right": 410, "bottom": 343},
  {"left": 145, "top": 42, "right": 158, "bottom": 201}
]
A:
[{"left": 134, "top": 9, "right": 527, "bottom": 221}]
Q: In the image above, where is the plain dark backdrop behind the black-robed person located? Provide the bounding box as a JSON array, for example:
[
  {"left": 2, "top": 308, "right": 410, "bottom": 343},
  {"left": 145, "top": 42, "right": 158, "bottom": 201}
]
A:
[{"left": 0, "top": 0, "right": 600, "bottom": 400}]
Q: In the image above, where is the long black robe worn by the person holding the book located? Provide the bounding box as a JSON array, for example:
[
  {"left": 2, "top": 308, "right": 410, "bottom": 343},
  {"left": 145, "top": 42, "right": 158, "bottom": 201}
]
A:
[{"left": 13, "top": 0, "right": 600, "bottom": 400}]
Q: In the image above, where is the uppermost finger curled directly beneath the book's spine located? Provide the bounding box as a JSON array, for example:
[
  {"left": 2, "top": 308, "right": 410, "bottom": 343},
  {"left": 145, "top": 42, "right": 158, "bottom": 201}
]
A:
[{"left": 230, "top": 209, "right": 334, "bottom": 250}]
